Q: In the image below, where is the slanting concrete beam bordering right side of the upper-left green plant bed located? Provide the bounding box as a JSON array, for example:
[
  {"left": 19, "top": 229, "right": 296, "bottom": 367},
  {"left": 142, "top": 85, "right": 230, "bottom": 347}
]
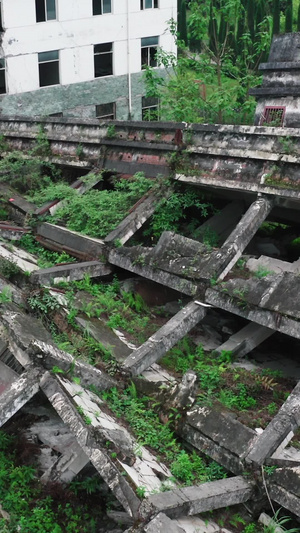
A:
[{"left": 104, "top": 191, "right": 171, "bottom": 244}]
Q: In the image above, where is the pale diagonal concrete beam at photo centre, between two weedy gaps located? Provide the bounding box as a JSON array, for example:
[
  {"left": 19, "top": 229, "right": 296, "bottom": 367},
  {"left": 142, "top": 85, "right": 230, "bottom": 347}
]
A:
[{"left": 123, "top": 302, "right": 206, "bottom": 376}]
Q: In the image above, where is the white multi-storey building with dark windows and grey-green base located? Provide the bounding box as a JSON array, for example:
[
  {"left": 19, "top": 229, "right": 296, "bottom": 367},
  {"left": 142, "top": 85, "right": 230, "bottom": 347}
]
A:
[{"left": 0, "top": 0, "right": 177, "bottom": 120}]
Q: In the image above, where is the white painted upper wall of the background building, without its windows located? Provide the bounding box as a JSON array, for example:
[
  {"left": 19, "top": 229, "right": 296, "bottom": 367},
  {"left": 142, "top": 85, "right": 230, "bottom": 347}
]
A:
[{"left": 2, "top": 0, "right": 177, "bottom": 94}]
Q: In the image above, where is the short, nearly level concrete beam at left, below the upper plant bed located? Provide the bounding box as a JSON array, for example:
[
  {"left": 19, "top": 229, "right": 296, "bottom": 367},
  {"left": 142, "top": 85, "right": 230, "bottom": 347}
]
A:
[{"left": 30, "top": 261, "right": 112, "bottom": 285}]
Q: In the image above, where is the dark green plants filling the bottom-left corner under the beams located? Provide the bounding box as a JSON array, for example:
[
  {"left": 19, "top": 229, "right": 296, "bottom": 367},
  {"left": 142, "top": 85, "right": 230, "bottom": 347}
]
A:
[{"left": 0, "top": 431, "right": 106, "bottom": 533}]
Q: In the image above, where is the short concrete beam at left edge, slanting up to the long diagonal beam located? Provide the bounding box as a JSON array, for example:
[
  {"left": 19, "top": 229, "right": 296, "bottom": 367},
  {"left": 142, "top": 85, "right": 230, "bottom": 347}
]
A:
[{"left": 0, "top": 368, "right": 44, "bottom": 427}]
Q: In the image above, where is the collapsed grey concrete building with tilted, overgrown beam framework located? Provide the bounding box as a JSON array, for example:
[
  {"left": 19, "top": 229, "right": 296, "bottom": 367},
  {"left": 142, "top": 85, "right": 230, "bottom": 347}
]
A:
[{"left": 0, "top": 112, "right": 300, "bottom": 532}]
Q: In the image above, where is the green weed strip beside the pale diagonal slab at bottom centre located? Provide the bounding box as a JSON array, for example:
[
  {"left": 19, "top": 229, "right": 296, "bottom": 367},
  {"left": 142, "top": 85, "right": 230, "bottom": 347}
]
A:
[{"left": 100, "top": 384, "right": 226, "bottom": 485}]
